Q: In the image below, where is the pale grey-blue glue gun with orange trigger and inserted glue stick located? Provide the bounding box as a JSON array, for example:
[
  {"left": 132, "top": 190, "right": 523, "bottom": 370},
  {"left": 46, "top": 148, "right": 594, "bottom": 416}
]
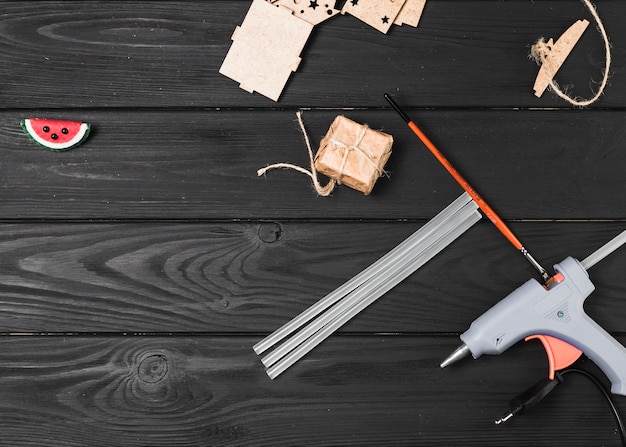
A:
[{"left": 441, "top": 231, "right": 626, "bottom": 395}]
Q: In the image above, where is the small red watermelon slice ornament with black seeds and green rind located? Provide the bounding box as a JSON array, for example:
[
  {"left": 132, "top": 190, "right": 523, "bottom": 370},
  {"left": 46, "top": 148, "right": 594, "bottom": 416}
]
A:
[{"left": 20, "top": 118, "right": 91, "bottom": 151}]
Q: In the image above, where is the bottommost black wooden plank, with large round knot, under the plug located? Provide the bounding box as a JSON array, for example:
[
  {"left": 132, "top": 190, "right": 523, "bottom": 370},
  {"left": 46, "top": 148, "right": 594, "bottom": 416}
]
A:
[{"left": 0, "top": 336, "right": 626, "bottom": 447}]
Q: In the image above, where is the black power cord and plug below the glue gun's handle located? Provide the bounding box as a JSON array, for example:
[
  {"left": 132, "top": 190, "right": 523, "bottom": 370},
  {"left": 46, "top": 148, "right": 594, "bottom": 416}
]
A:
[{"left": 495, "top": 368, "right": 626, "bottom": 447}]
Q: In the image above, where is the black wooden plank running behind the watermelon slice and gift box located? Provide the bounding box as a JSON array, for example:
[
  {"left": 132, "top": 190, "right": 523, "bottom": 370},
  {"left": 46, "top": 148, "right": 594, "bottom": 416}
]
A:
[{"left": 0, "top": 108, "right": 626, "bottom": 219}]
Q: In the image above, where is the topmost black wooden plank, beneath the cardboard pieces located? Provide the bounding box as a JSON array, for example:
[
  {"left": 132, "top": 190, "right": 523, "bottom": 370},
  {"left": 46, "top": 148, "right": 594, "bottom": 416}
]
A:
[{"left": 0, "top": 0, "right": 626, "bottom": 108}]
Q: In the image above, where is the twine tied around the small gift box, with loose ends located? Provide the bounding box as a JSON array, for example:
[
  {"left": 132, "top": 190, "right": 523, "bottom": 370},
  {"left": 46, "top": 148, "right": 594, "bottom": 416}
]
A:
[{"left": 257, "top": 110, "right": 385, "bottom": 197}]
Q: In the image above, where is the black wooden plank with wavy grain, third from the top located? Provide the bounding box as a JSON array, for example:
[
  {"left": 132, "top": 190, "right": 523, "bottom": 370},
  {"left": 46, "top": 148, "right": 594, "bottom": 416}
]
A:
[{"left": 0, "top": 222, "right": 626, "bottom": 332}]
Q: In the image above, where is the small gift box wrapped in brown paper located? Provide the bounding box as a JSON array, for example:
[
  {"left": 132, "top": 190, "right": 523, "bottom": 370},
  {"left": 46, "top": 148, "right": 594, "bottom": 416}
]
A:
[{"left": 314, "top": 115, "right": 393, "bottom": 195}]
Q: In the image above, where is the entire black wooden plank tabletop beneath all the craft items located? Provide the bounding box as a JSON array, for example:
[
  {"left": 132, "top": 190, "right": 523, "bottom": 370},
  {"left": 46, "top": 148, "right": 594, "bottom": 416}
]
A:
[{"left": 0, "top": 0, "right": 626, "bottom": 446}]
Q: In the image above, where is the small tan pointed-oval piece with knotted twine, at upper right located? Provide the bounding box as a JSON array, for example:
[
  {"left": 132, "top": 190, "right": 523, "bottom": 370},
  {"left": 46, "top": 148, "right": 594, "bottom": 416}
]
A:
[{"left": 531, "top": 20, "right": 589, "bottom": 98}]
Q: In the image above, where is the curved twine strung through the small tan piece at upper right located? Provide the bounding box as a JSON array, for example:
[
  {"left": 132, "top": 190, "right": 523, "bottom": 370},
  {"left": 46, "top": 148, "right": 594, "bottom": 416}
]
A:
[{"left": 529, "top": 0, "right": 611, "bottom": 107}]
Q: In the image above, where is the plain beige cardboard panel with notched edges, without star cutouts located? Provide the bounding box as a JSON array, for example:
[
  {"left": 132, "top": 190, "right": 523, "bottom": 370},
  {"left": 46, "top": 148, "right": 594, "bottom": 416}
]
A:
[{"left": 219, "top": 0, "right": 313, "bottom": 101}]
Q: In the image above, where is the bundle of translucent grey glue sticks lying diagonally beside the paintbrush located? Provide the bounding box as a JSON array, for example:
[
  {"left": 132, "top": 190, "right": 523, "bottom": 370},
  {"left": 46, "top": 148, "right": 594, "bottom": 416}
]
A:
[{"left": 254, "top": 193, "right": 481, "bottom": 379}]
